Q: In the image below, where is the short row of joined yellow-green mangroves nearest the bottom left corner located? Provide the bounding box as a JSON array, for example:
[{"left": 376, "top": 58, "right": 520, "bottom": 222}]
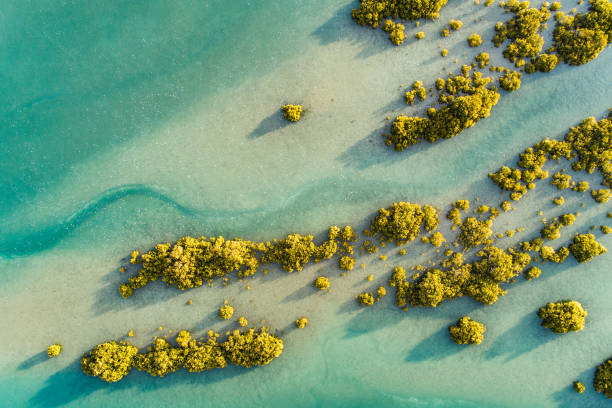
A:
[{"left": 81, "top": 328, "right": 283, "bottom": 383}]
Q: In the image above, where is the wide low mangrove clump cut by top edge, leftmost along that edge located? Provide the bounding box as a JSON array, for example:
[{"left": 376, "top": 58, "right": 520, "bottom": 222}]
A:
[{"left": 351, "top": 0, "right": 447, "bottom": 28}]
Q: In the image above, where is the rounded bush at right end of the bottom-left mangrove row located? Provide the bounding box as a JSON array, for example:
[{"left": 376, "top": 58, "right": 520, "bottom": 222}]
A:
[{"left": 222, "top": 328, "right": 283, "bottom": 367}]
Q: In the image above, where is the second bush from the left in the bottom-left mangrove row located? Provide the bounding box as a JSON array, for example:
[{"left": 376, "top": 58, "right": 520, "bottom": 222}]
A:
[{"left": 133, "top": 338, "right": 187, "bottom": 377}]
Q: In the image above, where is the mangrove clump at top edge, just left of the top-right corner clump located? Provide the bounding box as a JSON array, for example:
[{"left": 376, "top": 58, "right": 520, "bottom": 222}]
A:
[{"left": 493, "top": 0, "right": 550, "bottom": 62}]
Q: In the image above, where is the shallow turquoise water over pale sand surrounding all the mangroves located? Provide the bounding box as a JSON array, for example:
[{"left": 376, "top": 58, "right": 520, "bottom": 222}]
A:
[{"left": 0, "top": 0, "right": 612, "bottom": 407}]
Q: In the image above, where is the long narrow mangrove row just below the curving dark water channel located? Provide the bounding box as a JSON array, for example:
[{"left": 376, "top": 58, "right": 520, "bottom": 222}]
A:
[{"left": 119, "top": 226, "right": 357, "bottom": 298}]
